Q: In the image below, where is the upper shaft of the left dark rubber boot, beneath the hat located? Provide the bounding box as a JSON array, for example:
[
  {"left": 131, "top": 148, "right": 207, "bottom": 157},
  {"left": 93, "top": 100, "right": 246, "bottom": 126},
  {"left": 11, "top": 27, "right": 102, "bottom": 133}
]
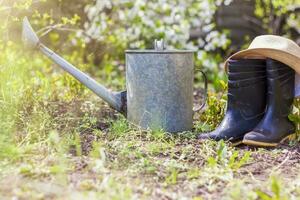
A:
[{"left": 227, "top": 59, "right": 267, "bottom": 119}]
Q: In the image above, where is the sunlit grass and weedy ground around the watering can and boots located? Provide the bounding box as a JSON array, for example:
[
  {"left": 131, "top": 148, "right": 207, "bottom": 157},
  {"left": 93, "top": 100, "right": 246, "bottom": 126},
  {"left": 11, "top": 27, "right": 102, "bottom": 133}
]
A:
[{"left": 0, "top": 43, "right": 300, "bottom": 200}]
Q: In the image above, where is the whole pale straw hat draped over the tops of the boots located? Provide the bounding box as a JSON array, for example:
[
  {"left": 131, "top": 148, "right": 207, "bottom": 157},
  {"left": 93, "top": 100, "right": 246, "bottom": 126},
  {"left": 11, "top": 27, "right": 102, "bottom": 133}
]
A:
[{"left": 225, "top": 35, "right": 300, "bottom": 74}]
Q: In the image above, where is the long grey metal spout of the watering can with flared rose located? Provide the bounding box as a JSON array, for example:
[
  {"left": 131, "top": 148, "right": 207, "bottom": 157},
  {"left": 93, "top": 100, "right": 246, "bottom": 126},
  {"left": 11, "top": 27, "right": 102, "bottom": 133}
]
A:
[{"left": 22, "top": 17, "right": 126, "bottom": 114}]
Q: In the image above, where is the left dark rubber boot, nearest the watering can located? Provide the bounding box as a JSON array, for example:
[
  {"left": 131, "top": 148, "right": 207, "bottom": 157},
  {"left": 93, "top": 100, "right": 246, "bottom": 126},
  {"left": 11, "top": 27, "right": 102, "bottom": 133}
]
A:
[{"left": 198, "top": 59, "right": 267, "bottom": 145}]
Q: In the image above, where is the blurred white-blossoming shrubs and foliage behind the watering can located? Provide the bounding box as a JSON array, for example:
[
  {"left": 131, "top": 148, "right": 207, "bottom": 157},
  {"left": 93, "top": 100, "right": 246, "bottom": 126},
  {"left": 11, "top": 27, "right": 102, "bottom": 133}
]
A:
[{"left": 0, "top": 0, "right": 300, "bottom": 89}]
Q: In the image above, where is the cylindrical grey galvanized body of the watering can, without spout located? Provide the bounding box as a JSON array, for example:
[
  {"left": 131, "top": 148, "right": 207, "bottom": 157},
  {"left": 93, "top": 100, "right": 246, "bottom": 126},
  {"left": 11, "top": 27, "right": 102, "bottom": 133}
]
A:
[{"left": 126, "top": 50, "right": 194, "bottom": 132}]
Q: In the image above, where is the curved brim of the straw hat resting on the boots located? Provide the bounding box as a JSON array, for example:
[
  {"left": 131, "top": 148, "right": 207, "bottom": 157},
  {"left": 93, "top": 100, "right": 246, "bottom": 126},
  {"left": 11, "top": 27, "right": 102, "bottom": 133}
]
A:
[{"left": 225, "top": 48, "right": 300, "bottom": 74}]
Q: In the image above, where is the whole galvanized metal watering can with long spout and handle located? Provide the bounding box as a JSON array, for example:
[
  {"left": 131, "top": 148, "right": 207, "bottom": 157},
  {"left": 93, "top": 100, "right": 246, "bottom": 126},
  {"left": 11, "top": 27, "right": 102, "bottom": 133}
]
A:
[{"left": 23, "top": 18, "right": 207, "bottom": 133}]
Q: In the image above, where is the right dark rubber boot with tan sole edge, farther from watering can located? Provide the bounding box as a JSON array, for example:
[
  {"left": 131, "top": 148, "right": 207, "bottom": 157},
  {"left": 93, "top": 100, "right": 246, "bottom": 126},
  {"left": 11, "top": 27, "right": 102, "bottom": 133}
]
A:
[{"left": 243, "top": 59, "right": 295, "bottom": 147}]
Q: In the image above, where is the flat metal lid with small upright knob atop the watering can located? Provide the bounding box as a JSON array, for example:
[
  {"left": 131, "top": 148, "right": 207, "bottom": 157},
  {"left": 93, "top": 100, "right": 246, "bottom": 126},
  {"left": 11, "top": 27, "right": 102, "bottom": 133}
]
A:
[{"left": 125, "top": 40, "right": 196, "bottom": 54}]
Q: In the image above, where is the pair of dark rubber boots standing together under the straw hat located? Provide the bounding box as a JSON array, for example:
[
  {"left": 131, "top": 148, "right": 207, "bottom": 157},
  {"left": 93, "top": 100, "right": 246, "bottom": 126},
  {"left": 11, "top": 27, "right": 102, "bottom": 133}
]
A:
[{"left": 199, "top": 59, "right": 295, "bottom": 147}]
